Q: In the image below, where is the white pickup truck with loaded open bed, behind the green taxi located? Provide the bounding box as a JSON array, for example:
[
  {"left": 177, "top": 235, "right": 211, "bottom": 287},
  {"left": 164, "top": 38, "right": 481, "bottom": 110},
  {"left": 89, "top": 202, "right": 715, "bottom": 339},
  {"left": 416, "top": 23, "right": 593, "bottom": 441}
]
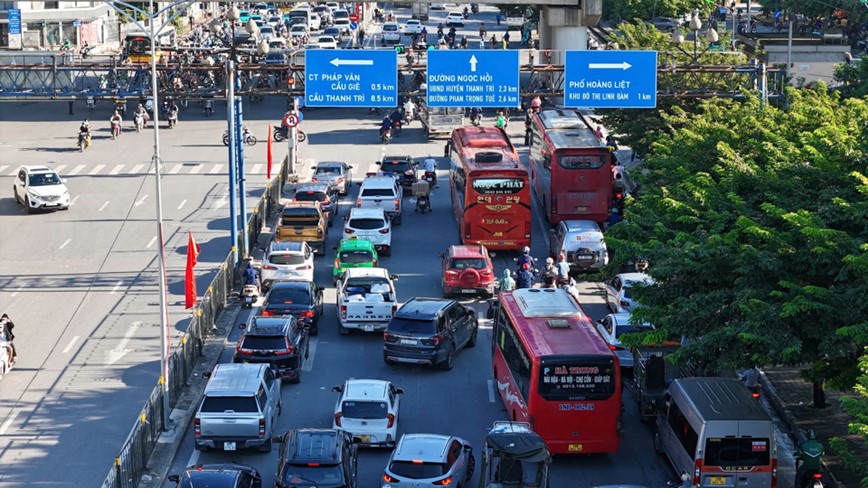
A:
[{"left": 337, "top": 268, "right": 398, "bottom": 335}]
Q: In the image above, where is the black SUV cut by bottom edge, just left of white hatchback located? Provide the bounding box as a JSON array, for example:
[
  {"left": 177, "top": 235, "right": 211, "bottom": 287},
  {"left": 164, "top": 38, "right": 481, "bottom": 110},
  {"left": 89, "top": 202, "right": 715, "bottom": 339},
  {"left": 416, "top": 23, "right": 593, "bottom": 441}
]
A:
[{"left": 274, "top": 429, "right": 359, "bottom": 488}]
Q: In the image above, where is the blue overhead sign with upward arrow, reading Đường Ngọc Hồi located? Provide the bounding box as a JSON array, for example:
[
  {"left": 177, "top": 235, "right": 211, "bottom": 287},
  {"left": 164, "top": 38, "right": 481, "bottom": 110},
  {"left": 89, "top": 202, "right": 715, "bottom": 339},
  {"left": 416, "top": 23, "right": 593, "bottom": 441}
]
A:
[{"left": 428, "top": 49, "right": 520, "bottom": 107}]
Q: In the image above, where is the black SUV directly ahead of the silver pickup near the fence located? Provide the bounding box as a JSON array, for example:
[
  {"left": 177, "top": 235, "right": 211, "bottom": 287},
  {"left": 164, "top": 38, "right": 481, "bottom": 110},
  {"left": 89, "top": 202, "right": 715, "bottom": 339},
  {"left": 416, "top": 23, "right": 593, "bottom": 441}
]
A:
[{"left": 232, "top": 316, "right": 310, "bottom": 383}]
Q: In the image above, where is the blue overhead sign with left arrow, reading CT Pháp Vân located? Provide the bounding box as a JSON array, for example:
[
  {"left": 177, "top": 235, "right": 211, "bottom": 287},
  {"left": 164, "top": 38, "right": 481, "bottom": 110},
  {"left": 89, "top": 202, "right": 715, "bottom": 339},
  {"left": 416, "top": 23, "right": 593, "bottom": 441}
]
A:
[{"left": 304, "top": 49, "right": 398, "bottom": 107}]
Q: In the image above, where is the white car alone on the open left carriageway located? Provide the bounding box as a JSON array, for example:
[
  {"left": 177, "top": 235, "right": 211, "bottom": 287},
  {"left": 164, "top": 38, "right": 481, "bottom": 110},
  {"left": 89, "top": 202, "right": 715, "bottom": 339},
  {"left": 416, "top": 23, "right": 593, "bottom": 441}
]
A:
[{"left": 12, "top": 166, "right": 70, "bottom": 213}]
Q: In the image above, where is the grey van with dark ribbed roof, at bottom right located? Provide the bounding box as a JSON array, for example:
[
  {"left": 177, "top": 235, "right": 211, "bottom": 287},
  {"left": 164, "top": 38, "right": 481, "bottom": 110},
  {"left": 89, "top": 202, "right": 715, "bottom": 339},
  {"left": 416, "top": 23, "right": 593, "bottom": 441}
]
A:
[{"left": 654, "top": 378, "right": 778, "bottom": 488}]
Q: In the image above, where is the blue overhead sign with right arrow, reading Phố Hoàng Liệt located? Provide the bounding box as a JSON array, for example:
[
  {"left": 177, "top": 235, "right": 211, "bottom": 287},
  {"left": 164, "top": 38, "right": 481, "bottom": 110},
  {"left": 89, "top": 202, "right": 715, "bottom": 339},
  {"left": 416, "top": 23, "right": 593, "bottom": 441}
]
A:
[{"left": 564, "top": 51, "right": 657, "bottom": 108}]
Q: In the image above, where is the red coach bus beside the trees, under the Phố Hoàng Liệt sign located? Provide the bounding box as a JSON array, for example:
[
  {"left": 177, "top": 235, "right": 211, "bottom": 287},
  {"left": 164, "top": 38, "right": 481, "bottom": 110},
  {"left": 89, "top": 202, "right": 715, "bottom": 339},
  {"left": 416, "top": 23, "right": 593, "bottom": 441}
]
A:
[{"left": 528, "top": 109, "right": 613, "bottom": 224}]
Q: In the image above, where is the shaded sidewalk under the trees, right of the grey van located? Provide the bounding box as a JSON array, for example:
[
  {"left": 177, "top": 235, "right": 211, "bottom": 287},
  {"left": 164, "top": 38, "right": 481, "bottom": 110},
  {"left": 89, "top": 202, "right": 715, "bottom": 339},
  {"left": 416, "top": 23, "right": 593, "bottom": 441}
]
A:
[{"left": 763, "top": 368, "right": 868, "bottom": 488}]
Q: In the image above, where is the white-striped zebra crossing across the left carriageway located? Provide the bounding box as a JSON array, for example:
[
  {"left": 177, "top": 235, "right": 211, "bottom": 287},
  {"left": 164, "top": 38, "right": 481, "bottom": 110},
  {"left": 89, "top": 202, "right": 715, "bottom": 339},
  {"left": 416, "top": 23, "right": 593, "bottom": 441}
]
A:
[{"left": 0, "top": 163, "right": 278, "bottom": 177}]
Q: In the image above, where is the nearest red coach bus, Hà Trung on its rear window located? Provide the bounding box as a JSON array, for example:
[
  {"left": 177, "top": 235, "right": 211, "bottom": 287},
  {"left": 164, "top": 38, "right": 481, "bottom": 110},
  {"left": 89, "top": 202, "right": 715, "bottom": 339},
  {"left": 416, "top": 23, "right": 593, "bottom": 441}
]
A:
[{"left": 492, "top": 288, "right": 621, "bottom": 454}]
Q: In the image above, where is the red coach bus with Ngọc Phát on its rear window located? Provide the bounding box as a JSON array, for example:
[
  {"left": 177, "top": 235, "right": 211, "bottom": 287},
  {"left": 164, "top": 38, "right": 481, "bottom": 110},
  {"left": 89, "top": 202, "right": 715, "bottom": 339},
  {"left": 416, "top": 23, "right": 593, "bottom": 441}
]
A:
[{"left": 446, "top": 127, "right": 531, "bottom": 249}]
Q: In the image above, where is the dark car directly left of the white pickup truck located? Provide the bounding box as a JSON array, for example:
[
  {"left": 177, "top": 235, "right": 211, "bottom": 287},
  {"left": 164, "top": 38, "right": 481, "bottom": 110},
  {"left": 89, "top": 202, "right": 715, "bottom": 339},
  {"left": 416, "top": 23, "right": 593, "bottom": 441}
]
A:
[{"left": 260, "top": 281, "right": 322, "bottom": 336}]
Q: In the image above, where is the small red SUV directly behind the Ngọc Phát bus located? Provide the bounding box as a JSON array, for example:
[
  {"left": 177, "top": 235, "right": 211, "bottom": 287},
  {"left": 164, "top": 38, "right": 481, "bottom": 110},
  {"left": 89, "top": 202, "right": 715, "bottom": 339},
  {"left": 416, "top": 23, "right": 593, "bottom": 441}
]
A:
[{"left": 441, "top": 245, "right": 497, "bottom": 297}]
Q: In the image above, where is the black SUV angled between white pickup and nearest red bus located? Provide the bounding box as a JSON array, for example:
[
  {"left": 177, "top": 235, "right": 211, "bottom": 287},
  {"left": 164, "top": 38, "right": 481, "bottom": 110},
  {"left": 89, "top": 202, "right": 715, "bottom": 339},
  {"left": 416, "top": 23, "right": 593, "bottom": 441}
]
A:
[{"left": 383, "top": 298, "right": 479, "bottom": 370}]
